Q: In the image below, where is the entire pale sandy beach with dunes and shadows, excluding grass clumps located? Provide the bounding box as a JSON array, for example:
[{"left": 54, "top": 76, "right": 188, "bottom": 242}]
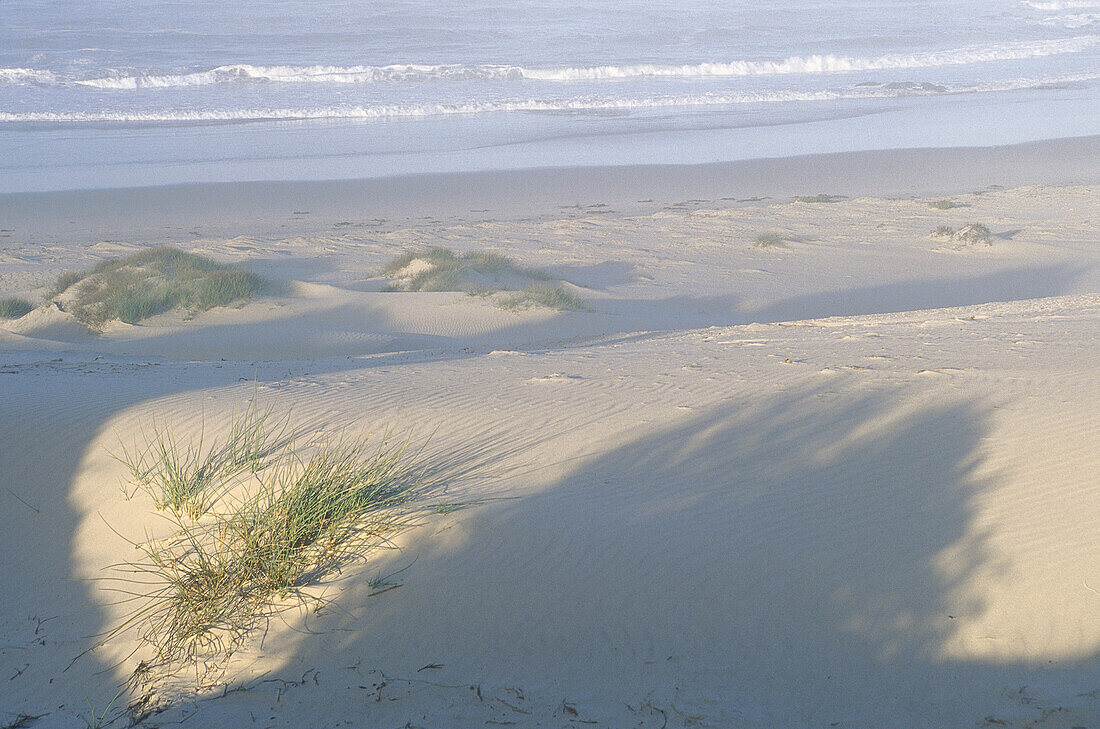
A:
[{"left": 0, "top": 139, "right": 1100, "bottom": 729}]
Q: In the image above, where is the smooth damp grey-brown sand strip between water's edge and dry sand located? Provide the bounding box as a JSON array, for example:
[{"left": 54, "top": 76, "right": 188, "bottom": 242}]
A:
[{"left": 0, "top": 135, "right": 1100, "bottom": 242}]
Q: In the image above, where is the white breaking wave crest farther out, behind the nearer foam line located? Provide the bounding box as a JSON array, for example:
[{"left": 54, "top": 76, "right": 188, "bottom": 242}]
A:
[{"left": 0, "top": 35, "right": 1100, "bottom": 90}]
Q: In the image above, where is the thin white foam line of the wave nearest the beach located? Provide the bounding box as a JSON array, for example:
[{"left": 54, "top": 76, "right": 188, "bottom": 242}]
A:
[{"left": 0, "top": 74, "right": 1100, "bottom": 123}]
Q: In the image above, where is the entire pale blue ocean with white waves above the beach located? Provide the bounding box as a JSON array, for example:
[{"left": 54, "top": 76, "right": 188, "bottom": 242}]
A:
[{"left": 0, "top": 0, "right": 1100, "bottom": 191}]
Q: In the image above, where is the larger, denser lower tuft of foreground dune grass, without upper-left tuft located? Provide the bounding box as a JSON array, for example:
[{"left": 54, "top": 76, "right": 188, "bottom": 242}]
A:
[{"left": 130, "top": 441, "right": 410, "bottom": 661}]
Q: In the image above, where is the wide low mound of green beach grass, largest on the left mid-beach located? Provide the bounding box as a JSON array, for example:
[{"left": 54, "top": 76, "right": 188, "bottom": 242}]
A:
[{"left": 50, "top": 246, "right": 270, "bottom": 328}]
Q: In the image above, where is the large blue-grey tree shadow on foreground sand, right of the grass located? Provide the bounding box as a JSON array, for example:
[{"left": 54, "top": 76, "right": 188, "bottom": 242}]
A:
[{"left": 167, "top": 388, "right": 1100, "bottom": 729}]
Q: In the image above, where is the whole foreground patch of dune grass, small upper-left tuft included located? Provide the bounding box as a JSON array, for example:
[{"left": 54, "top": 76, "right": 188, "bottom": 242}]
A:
[{"left": 103, "top": 400, "right": 418, "bottom": 665}]
